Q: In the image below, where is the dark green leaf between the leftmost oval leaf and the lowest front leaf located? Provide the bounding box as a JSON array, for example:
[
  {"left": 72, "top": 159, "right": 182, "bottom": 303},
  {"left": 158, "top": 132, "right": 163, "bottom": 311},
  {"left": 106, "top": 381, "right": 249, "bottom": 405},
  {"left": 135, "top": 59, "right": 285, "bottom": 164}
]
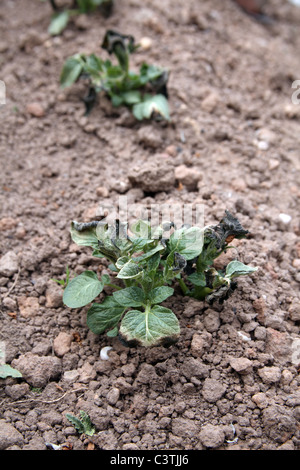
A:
[{"left": 87, "top": 296, "right": 125, "bottom": 335}]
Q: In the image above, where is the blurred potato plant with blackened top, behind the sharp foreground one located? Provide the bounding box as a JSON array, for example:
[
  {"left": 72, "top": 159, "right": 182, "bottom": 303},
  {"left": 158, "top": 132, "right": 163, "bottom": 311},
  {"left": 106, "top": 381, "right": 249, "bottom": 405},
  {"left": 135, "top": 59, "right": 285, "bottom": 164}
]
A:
[{"left": 60, "top": 30, "right": 170, "bottom": 120}]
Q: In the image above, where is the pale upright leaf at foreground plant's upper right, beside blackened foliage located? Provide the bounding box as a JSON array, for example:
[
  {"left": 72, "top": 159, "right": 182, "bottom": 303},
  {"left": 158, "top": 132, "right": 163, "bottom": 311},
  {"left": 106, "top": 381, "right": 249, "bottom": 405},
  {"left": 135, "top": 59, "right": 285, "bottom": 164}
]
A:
[{"left": 168, "top": 227, "right": 204, "bottom": 261}]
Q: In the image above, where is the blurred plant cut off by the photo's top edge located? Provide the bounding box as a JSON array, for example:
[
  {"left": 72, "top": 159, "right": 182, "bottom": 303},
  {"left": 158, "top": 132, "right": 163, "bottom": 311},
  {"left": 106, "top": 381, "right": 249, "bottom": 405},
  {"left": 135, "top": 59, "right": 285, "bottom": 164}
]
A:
[{"left": 48, "top": 0, "right": 113, "bottom": 36}]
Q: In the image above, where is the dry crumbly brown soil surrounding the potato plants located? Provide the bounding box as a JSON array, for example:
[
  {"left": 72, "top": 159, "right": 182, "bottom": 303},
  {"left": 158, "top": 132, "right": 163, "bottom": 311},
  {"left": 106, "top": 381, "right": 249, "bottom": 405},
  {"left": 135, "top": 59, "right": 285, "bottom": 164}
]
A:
[{"left": 0, "top": 0, "right": 300, "bottom": 450}]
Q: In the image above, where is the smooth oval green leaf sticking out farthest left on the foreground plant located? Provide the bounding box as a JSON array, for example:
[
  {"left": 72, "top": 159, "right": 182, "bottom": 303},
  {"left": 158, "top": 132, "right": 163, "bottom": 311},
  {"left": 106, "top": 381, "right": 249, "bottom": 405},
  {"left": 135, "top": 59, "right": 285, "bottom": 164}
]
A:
[{"left": 63, "top": 271, "right": 104, "bottom": 308}]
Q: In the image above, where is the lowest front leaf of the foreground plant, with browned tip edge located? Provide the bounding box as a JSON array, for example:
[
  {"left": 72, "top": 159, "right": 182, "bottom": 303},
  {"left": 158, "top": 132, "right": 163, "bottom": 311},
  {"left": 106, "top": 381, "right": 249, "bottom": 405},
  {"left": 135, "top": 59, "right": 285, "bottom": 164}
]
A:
[{"left": 120, "top": 305, "right": 180, "bottom": 346}]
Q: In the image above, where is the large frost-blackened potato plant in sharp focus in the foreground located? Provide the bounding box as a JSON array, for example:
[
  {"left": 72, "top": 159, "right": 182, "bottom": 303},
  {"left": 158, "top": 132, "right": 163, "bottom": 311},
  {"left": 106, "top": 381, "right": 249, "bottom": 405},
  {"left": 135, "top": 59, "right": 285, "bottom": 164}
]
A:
[{"left": 63, "top": 213, "right": 256, "bottom": 346}]
